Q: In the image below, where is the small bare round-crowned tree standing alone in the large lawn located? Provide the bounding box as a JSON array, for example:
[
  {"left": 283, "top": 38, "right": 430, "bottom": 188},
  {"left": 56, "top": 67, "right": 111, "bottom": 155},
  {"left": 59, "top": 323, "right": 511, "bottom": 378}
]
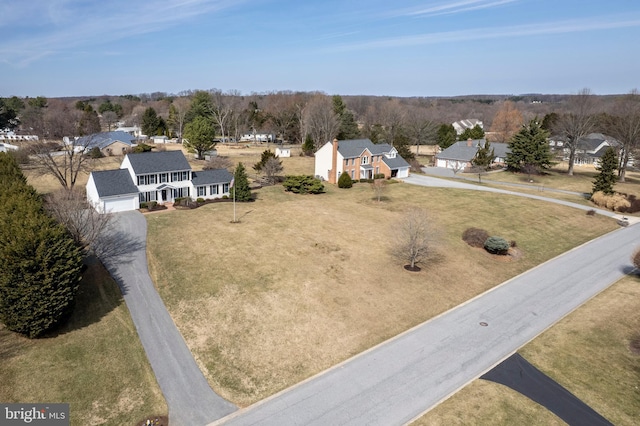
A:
[{"left": 393, "top": 208, "right": 435, "bottom": 271}]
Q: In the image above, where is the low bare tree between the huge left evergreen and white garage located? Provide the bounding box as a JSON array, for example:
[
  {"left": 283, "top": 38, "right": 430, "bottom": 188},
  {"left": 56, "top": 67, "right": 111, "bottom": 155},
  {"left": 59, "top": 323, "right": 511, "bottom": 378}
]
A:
[{"left": 45, "top": 189, "right": 113, "bottom": 254}]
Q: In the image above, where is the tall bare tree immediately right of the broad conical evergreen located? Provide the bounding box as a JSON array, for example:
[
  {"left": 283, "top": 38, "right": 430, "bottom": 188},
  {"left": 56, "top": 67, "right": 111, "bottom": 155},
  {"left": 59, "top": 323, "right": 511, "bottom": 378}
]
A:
[{"left": 553, "top": 88, "right": 596, "bottom": 176}]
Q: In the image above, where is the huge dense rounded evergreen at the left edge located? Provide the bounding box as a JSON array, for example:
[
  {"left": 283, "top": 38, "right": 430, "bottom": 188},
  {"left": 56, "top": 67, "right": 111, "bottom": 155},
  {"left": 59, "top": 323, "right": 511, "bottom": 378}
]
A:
[{"left": 0, "top": 153, "right": 82, "bottom": 338}]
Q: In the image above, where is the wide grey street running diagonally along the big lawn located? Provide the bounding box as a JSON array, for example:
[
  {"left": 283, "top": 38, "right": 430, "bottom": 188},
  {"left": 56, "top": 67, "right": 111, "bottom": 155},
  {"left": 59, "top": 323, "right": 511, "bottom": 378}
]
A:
[{"left": 213, "top": 176, "right": 640, "bottom": 425}]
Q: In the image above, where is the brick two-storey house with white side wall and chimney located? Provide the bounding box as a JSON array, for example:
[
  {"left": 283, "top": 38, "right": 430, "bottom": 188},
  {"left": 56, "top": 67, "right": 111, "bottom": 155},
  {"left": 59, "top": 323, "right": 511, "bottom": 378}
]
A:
[{"left": 315, "top": 139, "right": 410, "bottom": 183}]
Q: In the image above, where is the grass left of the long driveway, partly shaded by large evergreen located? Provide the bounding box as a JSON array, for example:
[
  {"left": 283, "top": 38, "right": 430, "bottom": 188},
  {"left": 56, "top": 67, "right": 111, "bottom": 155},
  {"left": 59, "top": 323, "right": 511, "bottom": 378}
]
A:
[{"left": 0, "top": 264, "right": 167, "bottom": 425}]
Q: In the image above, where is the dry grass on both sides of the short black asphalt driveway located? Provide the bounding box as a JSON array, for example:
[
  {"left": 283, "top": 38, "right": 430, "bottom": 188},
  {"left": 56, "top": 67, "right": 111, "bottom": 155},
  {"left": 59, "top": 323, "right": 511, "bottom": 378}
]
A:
[{"left": 413, "top": 276, "right": 640, "bottom": 426}]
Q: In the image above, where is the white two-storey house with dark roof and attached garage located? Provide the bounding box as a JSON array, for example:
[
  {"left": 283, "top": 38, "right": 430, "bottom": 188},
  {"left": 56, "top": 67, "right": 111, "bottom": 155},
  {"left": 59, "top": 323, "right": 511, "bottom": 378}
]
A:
[{"left": 87, "top": 151, "right": 233, "bottom": 212}]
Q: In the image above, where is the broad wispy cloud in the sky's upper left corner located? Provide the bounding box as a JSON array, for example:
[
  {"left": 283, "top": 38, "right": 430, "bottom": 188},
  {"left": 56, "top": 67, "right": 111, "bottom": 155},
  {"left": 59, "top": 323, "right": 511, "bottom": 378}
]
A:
[{"left": 0, "top": 0, "right": 245, "bottom": 67}]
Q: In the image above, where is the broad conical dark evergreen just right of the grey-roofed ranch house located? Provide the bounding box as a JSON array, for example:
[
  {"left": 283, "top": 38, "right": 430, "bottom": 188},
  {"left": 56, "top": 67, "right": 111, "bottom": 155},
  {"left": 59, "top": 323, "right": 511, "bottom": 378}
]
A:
[{"left": 505, "top": 118, "right": 552, "bottom": 171}]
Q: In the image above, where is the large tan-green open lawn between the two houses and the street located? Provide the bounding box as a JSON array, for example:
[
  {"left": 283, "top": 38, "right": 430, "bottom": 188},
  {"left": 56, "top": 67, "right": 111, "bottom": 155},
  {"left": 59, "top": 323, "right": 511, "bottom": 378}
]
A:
[{"left": 147, "top": 178, "right": 616, "bottom": 406}]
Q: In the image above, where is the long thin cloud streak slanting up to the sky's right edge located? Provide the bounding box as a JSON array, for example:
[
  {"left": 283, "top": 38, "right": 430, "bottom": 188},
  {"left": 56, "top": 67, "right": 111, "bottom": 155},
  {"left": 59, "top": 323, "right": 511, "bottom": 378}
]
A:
[{"left": 326, "top": 17, "right": 640, "bottom": 52}]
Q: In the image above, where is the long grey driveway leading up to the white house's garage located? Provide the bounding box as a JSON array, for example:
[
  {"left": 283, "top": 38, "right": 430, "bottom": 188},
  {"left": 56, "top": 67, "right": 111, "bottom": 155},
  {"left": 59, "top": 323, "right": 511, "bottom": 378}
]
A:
[{"left": 103, "top": 211, "right": 237, "bottom": 426}]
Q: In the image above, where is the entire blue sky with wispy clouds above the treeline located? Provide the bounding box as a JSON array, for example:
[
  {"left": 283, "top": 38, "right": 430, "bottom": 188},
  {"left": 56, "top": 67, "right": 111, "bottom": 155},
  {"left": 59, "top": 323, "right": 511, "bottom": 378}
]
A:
[{"left": 0, "top": 0, "right": 640, "bottom": 97}]
